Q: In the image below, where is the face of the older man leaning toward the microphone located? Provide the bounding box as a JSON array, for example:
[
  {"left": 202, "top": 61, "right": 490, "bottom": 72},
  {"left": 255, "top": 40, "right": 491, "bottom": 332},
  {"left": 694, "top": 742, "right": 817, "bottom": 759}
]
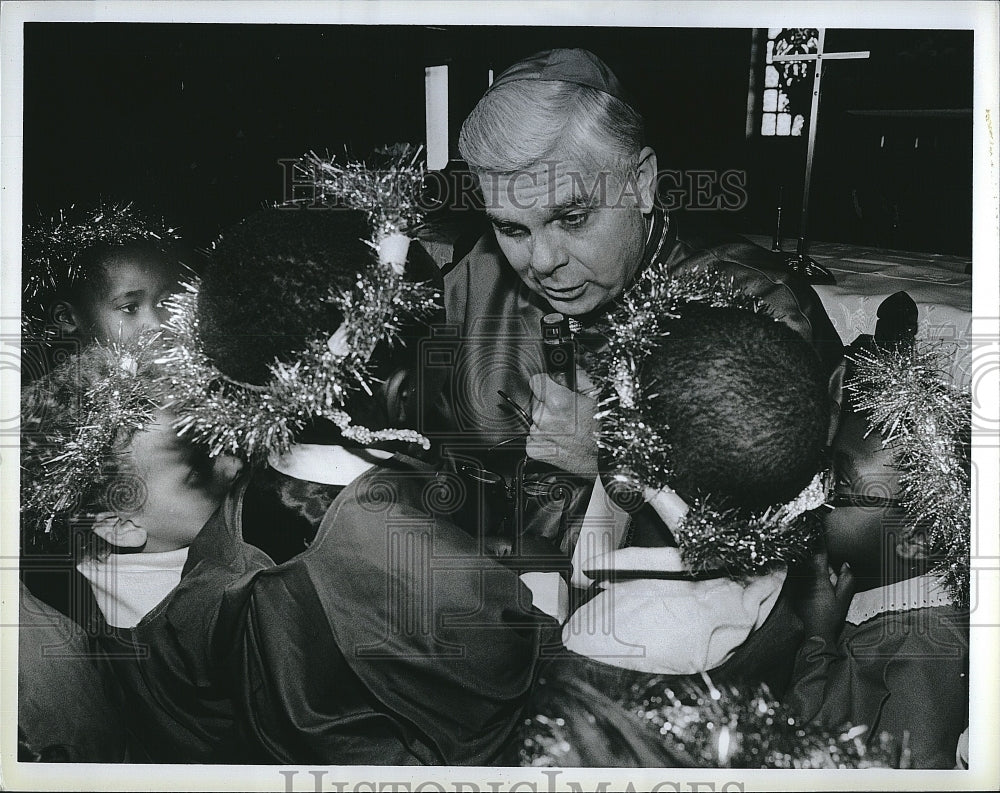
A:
[{"left": 480, "top": 149, "right": 656, "bottom": 316}]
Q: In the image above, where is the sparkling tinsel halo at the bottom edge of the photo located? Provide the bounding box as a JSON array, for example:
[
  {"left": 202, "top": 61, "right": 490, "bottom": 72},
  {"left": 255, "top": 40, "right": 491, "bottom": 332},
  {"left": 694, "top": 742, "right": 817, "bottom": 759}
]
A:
[{"left": 519, "top": 675, "right": 906, "bottom": 769}]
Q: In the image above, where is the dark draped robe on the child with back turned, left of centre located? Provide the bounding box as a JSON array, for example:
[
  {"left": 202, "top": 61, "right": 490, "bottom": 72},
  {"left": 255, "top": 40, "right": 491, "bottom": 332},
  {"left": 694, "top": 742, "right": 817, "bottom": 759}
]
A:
[{"left": 105, "top": 455, "right": 558, "bottom": 765}]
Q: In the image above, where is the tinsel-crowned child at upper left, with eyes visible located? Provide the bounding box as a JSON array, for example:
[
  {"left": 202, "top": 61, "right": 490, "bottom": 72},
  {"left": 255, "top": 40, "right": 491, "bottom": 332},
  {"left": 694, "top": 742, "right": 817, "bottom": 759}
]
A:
[{"left": 23, "top": 205, "right": 182, "bottom": 344}]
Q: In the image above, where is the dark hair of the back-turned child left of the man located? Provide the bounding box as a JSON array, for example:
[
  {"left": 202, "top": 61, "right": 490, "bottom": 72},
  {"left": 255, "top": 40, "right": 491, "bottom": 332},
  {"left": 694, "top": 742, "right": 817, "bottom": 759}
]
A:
[{"left": 198, "top": 207, "right": 440, "bottom": 385}]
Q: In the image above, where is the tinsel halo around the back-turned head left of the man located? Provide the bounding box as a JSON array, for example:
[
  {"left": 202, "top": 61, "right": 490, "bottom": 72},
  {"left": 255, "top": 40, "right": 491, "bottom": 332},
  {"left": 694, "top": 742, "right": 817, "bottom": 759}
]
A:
[{"left": 160, "top": 145, "right": 441, "bottom": 460}]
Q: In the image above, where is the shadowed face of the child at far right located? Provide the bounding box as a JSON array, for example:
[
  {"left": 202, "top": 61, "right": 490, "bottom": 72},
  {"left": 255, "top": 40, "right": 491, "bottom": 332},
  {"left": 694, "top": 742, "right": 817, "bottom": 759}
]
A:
[{"left": 823, "top": 413, "right": 906, "bottom": 575}]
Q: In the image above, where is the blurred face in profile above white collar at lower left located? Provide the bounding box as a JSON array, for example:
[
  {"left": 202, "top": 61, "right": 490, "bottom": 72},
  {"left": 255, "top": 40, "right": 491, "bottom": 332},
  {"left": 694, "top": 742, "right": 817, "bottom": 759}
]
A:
[{"left": 106, "top": 411, "right": 240, "bottom": 553}]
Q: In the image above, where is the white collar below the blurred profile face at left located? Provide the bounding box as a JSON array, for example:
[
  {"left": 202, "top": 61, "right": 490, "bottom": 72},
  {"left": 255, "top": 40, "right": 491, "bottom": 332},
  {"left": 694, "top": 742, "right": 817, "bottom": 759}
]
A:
[{"left": 77, "top": 547, "right": 188, "bottom": 628}]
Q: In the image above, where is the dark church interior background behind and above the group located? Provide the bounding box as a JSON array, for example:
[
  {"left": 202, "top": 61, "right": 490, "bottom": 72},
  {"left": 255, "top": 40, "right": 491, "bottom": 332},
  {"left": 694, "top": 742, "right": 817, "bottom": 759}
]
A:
[{"left": 24, "top": 23, "right": 973, "bottom": 254}]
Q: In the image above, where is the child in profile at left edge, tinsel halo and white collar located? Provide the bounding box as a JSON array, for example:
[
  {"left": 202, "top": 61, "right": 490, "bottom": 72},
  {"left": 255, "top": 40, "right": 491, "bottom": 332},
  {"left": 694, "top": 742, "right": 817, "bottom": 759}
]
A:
[{"left": 18, "top": 337, "right": 240, "bottom": 762}]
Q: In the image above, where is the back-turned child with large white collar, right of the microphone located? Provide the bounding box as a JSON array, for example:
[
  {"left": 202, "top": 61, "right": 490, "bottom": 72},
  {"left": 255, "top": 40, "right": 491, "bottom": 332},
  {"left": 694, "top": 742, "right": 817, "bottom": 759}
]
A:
[{"left": 563, "top": 296, "right": 830, "bottom": 689}]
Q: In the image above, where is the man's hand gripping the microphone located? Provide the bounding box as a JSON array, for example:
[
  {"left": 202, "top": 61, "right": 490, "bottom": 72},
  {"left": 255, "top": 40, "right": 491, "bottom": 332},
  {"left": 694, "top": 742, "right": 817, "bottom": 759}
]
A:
[{"left": 525, "top": 369, "right": 597, "bottom": 475}]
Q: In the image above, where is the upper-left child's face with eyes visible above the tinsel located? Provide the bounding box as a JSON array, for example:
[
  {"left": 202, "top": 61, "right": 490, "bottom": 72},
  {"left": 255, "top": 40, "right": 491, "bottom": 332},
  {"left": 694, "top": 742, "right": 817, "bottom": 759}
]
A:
[{"left": 84, "top": 254, "right": 180, "bottom": 342}]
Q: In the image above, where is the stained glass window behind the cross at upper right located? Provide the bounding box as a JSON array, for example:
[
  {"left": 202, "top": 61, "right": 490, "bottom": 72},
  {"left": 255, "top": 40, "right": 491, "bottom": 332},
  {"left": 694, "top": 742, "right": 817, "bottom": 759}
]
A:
[{"left": 753, "top": 28, "right": 819, "bottom": 137}]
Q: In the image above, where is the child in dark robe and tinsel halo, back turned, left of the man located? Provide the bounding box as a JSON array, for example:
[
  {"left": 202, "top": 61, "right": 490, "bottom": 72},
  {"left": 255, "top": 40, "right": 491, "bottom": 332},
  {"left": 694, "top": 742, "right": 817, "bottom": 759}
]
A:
[{"left": 68, "top": 201, "right": 546, "bottom": 765}]
